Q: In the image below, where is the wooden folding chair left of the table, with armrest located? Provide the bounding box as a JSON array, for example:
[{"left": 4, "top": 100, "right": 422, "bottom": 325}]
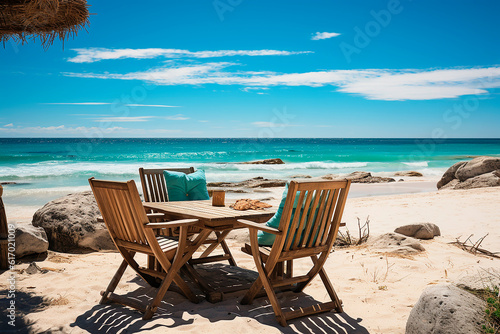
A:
[{"left": 89, "top": 178, "right": 210, "bottom": 320}]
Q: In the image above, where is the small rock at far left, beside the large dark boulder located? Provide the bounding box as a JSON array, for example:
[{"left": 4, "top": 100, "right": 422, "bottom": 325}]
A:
[{"left": 15, "top": 224, "right": 49, "bottom": 258}]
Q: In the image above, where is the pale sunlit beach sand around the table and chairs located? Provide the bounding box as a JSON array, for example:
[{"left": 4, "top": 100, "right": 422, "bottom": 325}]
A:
[{"left": 0, "top": 185, "right": 500, "bottom": 333}]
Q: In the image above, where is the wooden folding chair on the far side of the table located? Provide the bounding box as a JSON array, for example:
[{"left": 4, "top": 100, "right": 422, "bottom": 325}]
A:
[{"left": 139, "top": 167, "right": 236, "bottom": 266}]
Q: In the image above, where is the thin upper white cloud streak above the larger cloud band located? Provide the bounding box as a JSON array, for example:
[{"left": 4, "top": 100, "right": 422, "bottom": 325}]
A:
[{"left": 68, "top": 48, "right": 312, "bottom": 63}]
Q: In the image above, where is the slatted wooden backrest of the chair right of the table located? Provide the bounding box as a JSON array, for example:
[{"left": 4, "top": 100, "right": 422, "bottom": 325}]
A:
[{"left": 275, "top": 181, "right": 350, "bottom": 252}]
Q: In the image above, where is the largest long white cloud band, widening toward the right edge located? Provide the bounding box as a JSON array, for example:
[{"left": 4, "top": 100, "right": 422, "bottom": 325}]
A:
[{"left": 64, "top": 62, "right": 500, "bottom": 101}]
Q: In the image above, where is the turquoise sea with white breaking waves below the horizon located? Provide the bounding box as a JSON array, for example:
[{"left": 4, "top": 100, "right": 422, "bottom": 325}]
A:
[{"left": 0, "top": 138, "right": 500, "bottom": 205}]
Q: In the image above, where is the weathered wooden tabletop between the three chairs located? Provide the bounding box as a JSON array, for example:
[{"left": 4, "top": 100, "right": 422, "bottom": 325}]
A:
[{"left": 143, "top": 200, "right": 276, "bottom": 227}]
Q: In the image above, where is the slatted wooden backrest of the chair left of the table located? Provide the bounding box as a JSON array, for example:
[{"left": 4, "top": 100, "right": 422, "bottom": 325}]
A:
[{"left": 89, "top": 178, "right": 149, "bottom": 244}]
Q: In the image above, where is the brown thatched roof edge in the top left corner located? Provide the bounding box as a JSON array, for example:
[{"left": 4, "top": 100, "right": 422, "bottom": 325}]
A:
[{"left": 0, "top": 0, "right": 89, "bottom": 48}]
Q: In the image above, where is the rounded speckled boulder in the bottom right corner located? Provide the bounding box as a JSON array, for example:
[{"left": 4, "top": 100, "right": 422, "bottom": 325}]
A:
[{"left": 406, "top": 285, "right": 486, "bottom": 334}]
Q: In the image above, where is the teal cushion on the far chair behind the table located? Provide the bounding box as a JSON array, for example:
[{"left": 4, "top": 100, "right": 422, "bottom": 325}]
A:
[{"left": 163, "top": 169, "right": 210, "bottom": 201}]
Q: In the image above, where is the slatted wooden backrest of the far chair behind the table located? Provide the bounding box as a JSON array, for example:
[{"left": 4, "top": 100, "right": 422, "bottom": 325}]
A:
[{"left": 139, "top": 167, "right": 194, "bottom": 202}]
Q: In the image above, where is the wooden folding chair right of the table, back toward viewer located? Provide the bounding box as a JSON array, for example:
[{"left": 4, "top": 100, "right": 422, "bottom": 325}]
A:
[{"left": 238, "top": 181, "right": 350, "bottom": 326}]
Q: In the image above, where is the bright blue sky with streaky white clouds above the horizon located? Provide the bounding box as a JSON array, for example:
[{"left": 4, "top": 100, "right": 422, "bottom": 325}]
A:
[{"left": 0, "top": 0, "right": 500, "bottom": 138}]
